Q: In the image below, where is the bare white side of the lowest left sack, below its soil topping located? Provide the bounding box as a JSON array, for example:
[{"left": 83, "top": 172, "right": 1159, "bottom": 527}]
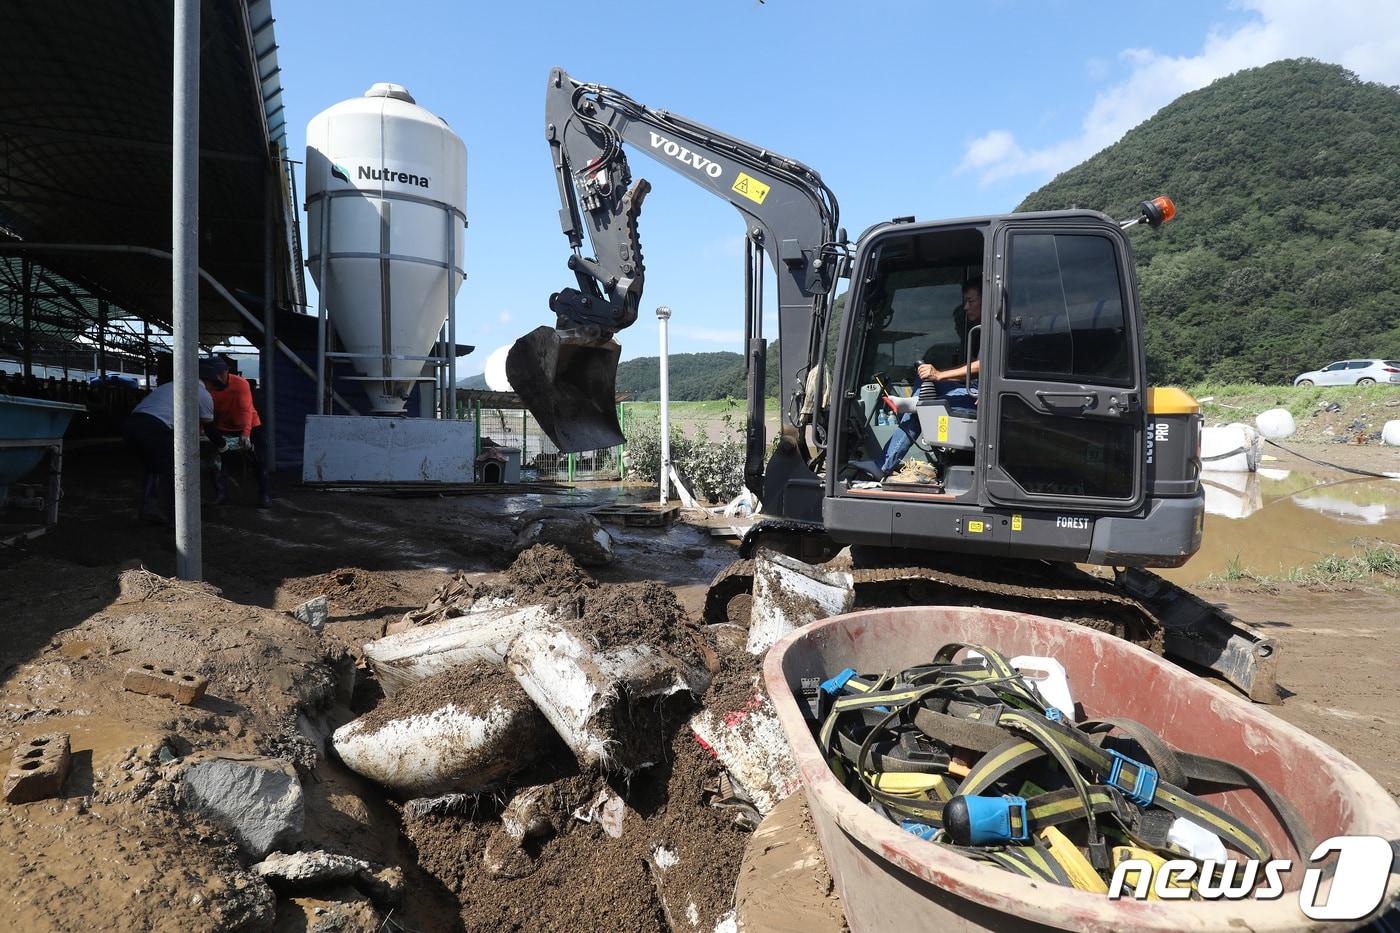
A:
[{"left": 330, "top": 681, "right": 549, "bottom": 797}]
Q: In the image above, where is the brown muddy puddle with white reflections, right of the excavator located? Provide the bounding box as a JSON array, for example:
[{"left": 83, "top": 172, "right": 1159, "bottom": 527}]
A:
[{"left": 1158, "top": 467, "right": 1400, "bottom": 583}]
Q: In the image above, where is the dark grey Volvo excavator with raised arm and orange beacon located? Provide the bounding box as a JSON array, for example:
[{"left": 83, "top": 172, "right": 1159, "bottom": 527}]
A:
[{"left": 507, "top": 69, "right": 1277, "bottom": 702}]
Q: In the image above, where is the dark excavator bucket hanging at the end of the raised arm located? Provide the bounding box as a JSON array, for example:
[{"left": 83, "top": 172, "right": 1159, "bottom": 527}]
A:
[{"left": 505, "top": 326, "right": 622, "bottom": 454}]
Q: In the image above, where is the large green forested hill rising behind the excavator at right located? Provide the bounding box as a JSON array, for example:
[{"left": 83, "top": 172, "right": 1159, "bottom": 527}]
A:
[{"left": 1019, "top": 59, "right": 1400, "bottom": 384}]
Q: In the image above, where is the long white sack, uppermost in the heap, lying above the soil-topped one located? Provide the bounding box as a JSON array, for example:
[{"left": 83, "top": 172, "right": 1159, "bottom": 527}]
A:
[{"left": 364, "top": 605, "right": 550, "bottom": 696}]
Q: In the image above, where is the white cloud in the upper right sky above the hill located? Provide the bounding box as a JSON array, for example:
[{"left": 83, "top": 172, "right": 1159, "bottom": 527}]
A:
[{"left": 959, "top": 0, "right": 1400, "bottom": 184}]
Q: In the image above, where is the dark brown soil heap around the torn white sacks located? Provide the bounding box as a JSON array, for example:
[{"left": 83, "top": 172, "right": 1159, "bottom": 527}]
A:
[{"left": 352, "top": 560, "right": 778, "bottom": 933}]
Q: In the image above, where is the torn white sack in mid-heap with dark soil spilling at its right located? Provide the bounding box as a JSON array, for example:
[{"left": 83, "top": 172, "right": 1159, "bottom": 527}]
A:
[{"left": 505, "top": 623, "right": 710, "bottom": 773}]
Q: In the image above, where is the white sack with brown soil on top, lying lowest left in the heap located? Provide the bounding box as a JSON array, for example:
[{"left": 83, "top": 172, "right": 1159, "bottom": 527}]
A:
[{"left": 332, "top": 664, "right": 552, "bottom": 797}]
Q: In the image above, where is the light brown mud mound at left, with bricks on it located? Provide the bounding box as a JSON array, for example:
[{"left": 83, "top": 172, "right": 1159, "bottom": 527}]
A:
[{"left": 0, "top": 565, "right": 445, "bottom": 930}]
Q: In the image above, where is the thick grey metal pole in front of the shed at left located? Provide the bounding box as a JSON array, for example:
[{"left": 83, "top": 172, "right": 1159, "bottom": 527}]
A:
[{"left": 171, "top": 0, "right": 204, "bottom": 580}]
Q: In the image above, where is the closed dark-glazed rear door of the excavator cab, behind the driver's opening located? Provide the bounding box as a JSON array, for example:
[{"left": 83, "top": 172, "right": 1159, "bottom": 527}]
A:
[{"left": 979, "top": 217, "right": 1147, "bottom": 512}]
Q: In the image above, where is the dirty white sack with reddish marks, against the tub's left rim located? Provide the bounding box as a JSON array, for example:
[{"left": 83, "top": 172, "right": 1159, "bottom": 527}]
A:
[{"left": 690, "top": 689, "right": 801, "bottom": 817}]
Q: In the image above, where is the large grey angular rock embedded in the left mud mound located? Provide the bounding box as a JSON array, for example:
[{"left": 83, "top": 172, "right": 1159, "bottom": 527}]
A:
[{"left": 179, "top": 752, "right": 305, "bottom": 859}]
